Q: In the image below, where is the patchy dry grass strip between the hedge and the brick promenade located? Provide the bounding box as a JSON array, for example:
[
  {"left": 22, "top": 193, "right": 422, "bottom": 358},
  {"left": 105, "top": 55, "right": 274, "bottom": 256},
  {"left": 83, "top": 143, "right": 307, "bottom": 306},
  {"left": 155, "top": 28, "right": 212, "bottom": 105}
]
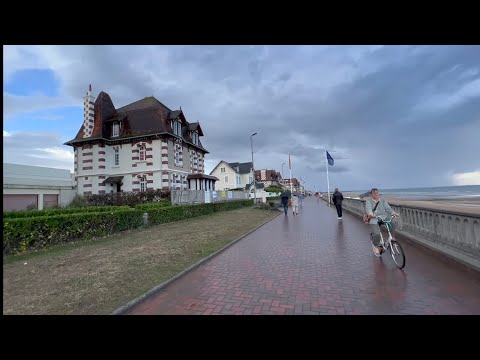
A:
[{"left": 3, "top": 207, "right": 279, "bottom": 315}]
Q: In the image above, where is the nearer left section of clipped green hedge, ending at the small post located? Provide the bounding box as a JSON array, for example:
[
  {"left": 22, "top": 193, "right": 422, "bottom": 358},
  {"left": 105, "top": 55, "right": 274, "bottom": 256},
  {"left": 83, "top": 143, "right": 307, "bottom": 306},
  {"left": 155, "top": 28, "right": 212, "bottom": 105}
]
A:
[{"left": 3, "top": 209, "right": 143, "bottom": 253}]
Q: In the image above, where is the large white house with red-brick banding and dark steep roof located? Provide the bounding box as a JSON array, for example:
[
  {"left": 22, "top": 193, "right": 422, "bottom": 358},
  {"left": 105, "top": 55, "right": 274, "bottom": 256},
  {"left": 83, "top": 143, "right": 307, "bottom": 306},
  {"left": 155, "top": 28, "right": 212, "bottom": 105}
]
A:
[{"left": 65, "top": 88, "right": 212, "bottom": 195}]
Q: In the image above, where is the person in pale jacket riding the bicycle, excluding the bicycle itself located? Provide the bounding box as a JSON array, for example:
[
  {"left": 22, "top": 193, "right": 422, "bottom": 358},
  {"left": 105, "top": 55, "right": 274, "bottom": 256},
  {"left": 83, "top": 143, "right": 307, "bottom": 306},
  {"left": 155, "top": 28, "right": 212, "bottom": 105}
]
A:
[{"left": 365, "top": 188, "right": 399, "bottom": 254}]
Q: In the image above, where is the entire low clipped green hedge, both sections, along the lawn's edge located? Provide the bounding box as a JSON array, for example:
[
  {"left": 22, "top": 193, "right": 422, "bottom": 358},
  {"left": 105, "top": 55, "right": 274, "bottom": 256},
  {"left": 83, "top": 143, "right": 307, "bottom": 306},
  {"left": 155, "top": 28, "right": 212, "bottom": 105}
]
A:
[{"left": 3, "top": 200, "right": 253, "bottom": 253}]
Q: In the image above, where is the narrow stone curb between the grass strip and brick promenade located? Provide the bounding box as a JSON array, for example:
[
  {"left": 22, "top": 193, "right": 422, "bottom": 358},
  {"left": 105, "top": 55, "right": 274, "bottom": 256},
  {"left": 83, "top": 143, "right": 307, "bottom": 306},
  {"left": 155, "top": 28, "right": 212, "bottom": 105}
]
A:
[{"left": 110, "top": 208, "right": 282, "bottom": 315}]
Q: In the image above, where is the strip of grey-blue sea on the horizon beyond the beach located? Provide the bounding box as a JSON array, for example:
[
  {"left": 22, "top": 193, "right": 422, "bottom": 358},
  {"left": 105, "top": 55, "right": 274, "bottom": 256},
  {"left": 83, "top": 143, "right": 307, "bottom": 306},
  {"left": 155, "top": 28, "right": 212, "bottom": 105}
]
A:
[{"left": 351, "top": 185, "right": 480, "bottom": 201}]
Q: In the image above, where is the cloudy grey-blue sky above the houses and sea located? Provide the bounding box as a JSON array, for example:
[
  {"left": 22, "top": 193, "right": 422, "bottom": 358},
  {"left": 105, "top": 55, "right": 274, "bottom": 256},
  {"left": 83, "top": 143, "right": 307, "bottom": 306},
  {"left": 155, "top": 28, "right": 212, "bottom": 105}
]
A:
[{"left": 3, "top": 45, "right": 480, "bottom": 191}]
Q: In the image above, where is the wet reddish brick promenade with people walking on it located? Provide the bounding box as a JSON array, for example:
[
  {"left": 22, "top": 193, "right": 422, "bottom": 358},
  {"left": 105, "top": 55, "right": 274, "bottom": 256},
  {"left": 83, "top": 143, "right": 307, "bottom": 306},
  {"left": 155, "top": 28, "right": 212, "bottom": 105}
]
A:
[{"left": 124, "top": 198, "right": 480, "bottom": 315}]
